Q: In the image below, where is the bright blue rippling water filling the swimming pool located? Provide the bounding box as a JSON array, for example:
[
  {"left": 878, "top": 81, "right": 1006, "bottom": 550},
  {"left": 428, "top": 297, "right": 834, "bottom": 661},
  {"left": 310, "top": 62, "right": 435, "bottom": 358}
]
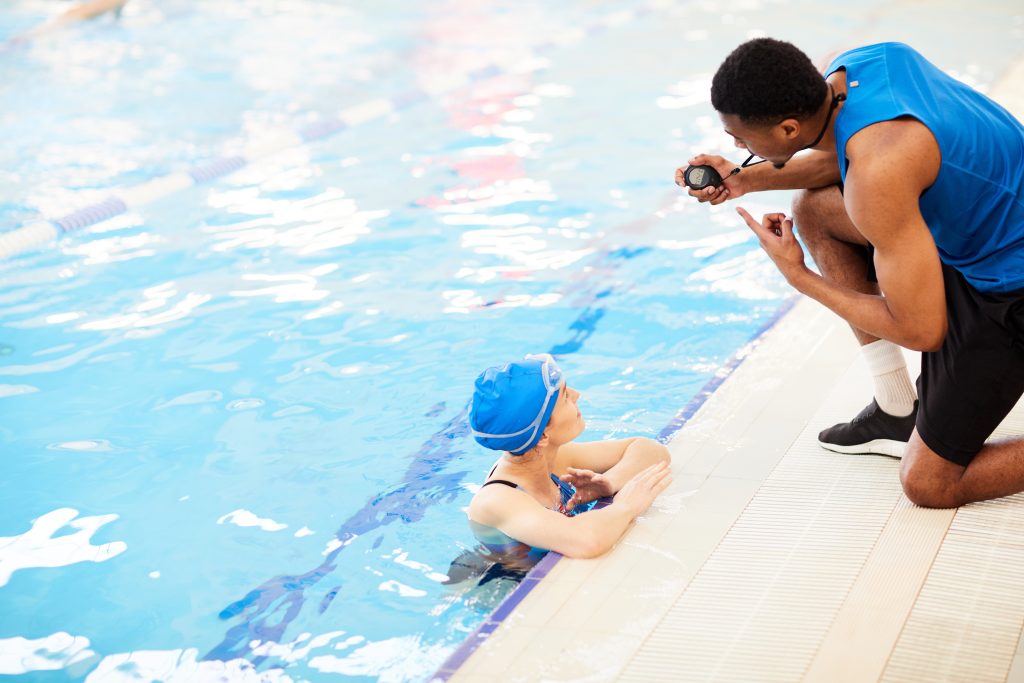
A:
[{"left": 0, "top": 0, "right": 1021, "bottom": 681}]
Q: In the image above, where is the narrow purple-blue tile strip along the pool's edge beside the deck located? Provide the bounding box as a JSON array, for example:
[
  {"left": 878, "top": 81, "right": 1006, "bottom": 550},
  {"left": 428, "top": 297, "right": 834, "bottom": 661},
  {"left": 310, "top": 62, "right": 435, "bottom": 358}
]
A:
[{"left": 429, "top": 295, "right": 801, "bottom": 683}]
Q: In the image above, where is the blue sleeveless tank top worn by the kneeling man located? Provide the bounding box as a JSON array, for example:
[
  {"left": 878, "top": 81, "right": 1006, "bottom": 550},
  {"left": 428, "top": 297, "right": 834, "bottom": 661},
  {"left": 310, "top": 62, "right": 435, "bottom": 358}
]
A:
[{"left": 825, "top": 43, "right": 1024, "bottom": 292}]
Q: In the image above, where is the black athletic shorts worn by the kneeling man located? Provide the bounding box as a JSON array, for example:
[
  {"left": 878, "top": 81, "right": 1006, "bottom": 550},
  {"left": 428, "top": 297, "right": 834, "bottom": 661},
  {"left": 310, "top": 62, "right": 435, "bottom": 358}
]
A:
[{"left": 918, "top": 264, "right": 1024, "bottom": 467}]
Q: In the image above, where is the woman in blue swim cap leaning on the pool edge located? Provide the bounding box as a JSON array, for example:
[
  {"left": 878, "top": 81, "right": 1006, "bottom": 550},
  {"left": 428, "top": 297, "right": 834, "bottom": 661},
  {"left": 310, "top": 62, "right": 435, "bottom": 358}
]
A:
[{"left": 469, "top": 354, "right": 672, "bottom": 559}]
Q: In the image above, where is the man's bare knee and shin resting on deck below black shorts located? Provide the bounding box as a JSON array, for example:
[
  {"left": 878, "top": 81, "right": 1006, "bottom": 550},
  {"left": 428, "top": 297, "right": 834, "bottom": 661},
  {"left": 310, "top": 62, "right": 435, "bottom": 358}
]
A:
[{"left": 899, "top": 430, "right": 1024, "bottom": 508}]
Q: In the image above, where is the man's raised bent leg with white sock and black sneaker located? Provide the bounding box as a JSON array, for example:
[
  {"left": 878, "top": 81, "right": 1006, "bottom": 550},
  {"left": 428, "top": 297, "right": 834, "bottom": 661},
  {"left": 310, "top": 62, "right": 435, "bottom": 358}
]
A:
[{"left": 793, "top": 186, "right": 916, "bottom": 457}]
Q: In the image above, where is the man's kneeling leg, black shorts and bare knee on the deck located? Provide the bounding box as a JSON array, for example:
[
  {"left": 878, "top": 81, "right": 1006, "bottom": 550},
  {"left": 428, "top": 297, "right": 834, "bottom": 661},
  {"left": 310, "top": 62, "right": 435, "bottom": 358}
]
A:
[{"left": 900, "top": 265, "right": 1024, "bottom": 508}]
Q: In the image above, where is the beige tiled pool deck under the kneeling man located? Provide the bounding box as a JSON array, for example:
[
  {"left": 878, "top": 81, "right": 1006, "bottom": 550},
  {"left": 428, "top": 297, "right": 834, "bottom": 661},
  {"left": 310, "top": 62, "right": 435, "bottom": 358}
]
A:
[{"left": 451, "top": 53, "right": 1024, "bottom": 683}]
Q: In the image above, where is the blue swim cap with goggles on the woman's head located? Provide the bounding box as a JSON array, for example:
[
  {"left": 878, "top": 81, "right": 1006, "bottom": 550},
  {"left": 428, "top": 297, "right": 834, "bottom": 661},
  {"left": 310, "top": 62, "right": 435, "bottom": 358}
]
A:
[{"left": 469, "top": 353, "right": 562, "bottom": 456}]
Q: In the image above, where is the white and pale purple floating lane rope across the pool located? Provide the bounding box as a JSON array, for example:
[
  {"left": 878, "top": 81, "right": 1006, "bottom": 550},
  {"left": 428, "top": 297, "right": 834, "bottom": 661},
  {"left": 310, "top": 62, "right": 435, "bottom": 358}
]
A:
[{"left": 0, "top": 0, "right": 676, "bottom": 260}]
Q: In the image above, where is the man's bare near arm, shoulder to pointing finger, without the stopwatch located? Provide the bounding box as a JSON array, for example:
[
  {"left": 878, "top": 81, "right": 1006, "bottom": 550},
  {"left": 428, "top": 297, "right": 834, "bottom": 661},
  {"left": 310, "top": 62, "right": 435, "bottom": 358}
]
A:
[{"left": 743, "top": 120, "right": 946, "bottom": 351}]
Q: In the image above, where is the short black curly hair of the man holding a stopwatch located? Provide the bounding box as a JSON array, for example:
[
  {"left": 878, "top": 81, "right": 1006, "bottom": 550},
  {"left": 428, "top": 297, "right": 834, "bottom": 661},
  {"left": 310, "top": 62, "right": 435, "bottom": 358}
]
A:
[{"left": 711, "top": 38, "right": 828, "bottom": 125}]
